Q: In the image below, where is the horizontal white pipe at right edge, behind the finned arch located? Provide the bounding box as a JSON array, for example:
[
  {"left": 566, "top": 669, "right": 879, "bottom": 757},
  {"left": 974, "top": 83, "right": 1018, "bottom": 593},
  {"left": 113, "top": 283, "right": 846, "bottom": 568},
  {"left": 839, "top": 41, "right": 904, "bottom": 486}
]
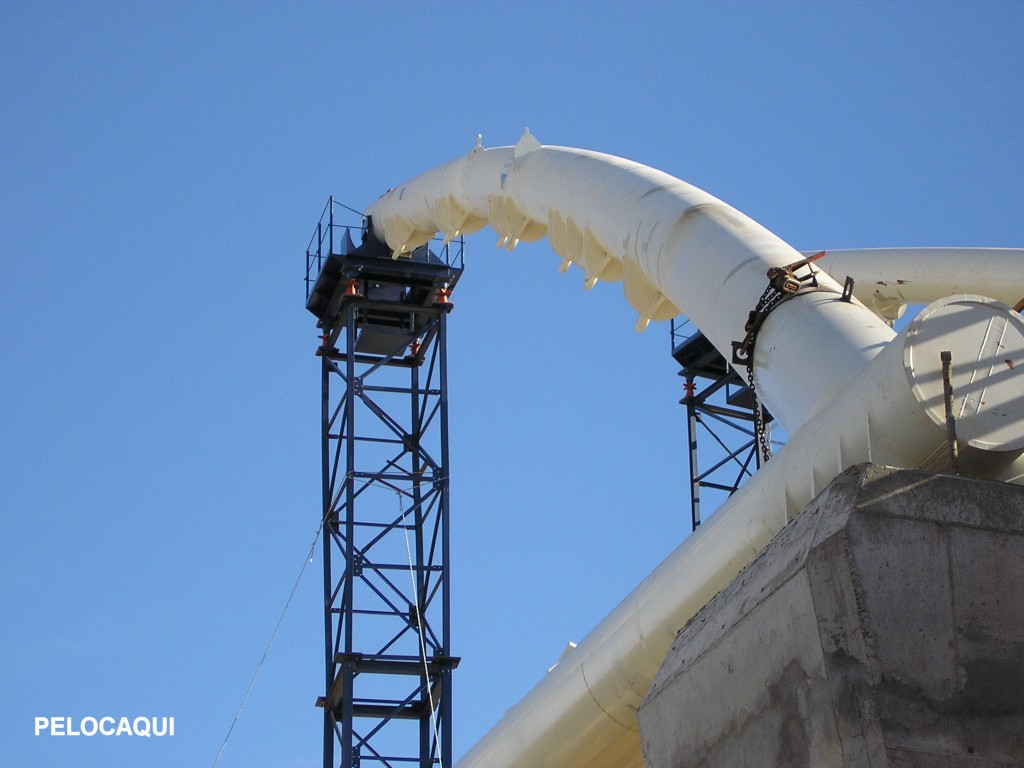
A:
[{"left": 805, "top": 248, "right": 1024, "bottom": 322}]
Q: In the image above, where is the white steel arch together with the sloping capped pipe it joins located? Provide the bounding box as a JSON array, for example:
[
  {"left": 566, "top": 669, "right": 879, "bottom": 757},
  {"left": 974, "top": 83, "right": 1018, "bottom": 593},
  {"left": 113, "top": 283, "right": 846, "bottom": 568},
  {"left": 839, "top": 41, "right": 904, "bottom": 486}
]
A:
[{"left": 367, "top": 135, "right": 1024, "bottom": 768}]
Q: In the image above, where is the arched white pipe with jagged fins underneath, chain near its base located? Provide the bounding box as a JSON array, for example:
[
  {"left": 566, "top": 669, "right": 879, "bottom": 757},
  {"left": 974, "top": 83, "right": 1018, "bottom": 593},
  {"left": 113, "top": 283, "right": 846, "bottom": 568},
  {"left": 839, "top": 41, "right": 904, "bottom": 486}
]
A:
[{"left": 366, "top": 132, "right": 894, "bottom": 434}]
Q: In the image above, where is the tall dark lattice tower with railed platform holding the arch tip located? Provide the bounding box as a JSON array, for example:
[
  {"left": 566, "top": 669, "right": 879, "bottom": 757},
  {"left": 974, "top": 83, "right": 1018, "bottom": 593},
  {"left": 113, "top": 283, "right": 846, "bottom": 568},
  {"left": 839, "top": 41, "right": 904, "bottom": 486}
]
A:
[{"left": 306, "top": 198, "right": 463, "bottom": 768}]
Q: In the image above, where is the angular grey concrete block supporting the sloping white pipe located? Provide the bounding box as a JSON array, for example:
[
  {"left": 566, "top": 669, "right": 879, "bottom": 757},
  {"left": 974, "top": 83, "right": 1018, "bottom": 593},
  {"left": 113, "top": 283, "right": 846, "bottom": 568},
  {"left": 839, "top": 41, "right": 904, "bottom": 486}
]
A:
[{"left": 639, "top": 465, "right": 1024, "bottom": 768}]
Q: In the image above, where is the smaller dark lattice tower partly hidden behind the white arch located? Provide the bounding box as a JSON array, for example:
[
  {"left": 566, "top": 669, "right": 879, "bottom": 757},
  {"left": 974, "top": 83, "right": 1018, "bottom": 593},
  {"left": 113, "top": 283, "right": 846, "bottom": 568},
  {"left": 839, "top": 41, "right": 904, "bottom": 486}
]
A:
[{"left": 671, "top": 321, "right": 772, "bottom": 529}]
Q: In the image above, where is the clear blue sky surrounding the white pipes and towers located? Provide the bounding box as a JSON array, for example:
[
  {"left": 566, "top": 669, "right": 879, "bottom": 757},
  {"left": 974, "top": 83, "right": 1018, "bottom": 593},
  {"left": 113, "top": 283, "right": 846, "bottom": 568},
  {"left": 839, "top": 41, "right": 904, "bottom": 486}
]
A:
[{"left": 0, "top": 0, "right": 1024, "bottom": 768}]
